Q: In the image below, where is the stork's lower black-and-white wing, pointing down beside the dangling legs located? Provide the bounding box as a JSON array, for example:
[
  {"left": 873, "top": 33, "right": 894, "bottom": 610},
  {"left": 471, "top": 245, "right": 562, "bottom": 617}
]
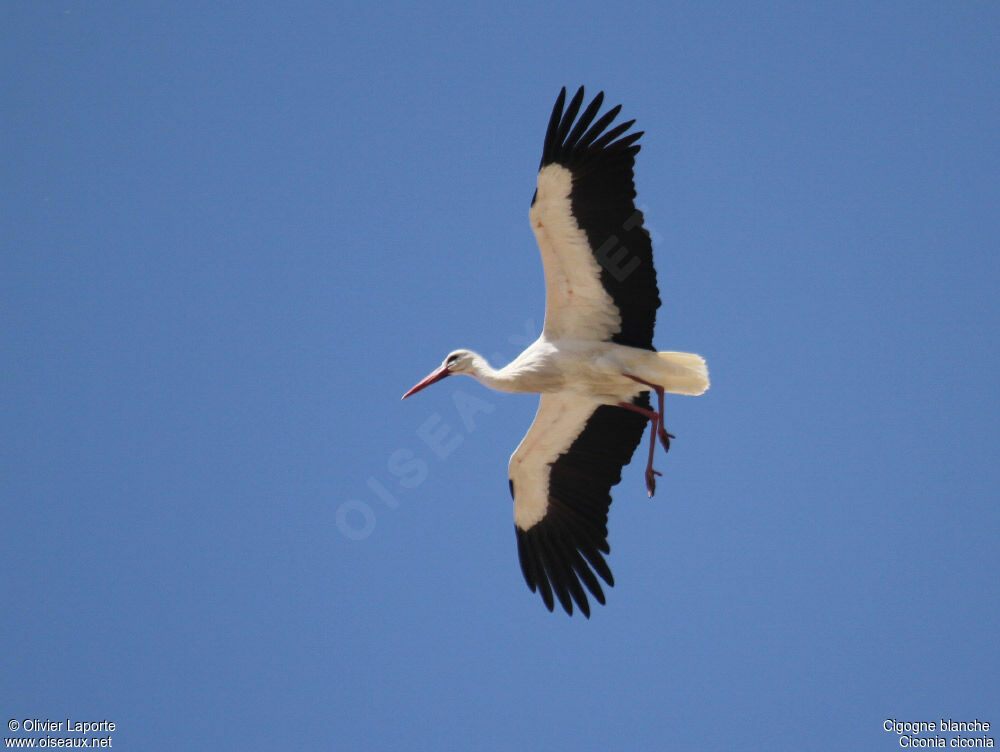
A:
[{"left": 509, "top": 392, "right": 649, "bottom": 617}]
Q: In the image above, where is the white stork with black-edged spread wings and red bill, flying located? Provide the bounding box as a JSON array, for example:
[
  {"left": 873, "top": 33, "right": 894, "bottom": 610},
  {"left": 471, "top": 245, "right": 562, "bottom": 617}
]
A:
[{"left": 403, "top": 87, "right": 709, "bottom": 617}]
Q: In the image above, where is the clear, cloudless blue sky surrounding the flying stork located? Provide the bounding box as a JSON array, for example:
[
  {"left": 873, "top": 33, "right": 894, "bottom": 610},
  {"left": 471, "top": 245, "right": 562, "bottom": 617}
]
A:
[{"left": 0, "top": 1, "right": 1000, "bottom": 750}]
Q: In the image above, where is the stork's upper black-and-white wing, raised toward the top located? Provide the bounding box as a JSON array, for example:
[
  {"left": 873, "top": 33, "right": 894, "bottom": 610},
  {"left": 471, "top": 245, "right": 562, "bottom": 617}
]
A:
[{"left": 530, "top": 87, "right": 660, "bottom": 350}]
